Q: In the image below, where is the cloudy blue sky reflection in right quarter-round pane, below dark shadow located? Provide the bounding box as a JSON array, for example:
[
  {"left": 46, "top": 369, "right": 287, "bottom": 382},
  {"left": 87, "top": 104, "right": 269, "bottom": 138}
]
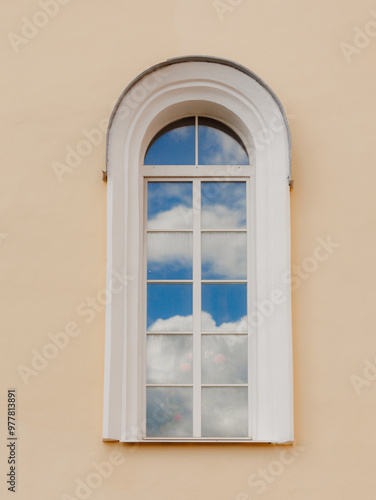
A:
[{"left": 201, "top": 128, "right": 249, "bottom": 165}]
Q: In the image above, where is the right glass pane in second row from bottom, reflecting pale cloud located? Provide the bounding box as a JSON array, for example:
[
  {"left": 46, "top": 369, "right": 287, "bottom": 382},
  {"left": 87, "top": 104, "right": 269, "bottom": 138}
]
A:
[{"left": 201, "top": 335, "right": 248, "bottom": 384}]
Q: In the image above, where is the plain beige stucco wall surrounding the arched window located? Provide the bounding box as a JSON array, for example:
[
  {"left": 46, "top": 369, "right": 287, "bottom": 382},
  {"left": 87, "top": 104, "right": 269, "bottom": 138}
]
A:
[{"left": 0, "top": 0, "right": 376, "bottom": 500}]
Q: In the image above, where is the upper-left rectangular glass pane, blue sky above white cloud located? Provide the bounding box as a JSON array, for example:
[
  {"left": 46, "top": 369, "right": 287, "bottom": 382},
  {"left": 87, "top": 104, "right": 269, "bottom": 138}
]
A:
[{"left": 147, "top": 182, "right": 192, "bottom": 230}]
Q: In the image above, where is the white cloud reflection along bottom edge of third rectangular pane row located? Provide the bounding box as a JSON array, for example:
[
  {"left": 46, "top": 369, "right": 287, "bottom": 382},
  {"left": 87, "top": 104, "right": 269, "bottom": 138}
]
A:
[{"left": 148, "top": 311, "right": 247, "bottom": 333}]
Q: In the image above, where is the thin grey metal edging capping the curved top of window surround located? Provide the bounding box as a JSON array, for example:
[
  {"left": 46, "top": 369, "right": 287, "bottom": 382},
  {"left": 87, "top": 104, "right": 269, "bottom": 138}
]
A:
[{"left": 103, "top": 56, "right": 291, "bottom": 183}]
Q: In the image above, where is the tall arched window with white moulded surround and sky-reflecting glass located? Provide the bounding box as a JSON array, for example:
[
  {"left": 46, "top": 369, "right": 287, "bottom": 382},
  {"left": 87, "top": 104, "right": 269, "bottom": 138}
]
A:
[{"left": 104, "top": 58, "right": 293, "bottom": 442}]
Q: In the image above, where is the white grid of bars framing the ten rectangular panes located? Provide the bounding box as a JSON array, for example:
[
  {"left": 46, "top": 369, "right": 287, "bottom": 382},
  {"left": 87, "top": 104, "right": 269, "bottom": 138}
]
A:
[{"left": 143, "top": 175, "right": 254, "bottom": 440}]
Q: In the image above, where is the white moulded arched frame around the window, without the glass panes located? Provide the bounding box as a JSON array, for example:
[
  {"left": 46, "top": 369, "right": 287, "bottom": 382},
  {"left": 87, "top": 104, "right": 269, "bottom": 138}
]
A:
[{"left": 103, "top": 57, "right": 294, "bottom": 444}]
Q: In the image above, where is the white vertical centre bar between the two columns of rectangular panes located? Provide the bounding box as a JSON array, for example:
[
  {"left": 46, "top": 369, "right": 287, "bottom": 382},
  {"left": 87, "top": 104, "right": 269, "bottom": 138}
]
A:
[{"left": 193, "top": 180, "right": 201, "bottom": 437}]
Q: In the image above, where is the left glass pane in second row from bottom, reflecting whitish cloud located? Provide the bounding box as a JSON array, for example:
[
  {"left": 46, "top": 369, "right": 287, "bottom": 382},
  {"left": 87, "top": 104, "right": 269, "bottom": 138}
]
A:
[{"left": 146, "top": 335, "right": 193, "bottom": 384}]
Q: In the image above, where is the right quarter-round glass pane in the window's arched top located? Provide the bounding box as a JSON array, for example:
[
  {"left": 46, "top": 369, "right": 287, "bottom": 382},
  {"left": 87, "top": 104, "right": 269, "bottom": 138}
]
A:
[{"left": 198, "top": 118, "right": 249, "bottom": 165}]
